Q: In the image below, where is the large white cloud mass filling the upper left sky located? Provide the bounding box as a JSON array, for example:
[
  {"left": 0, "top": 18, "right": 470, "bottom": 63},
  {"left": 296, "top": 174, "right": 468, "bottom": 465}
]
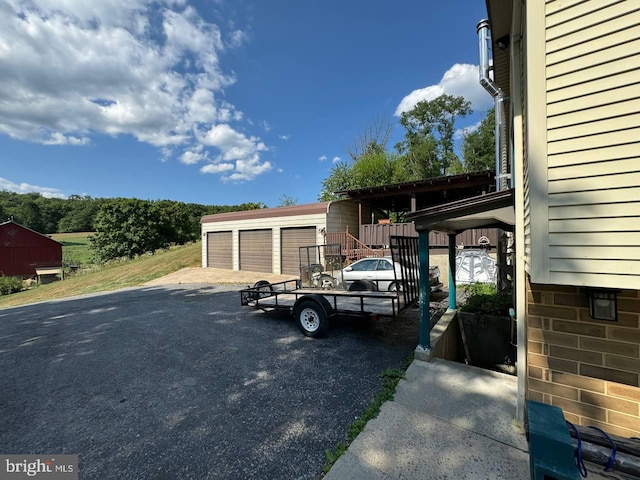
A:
[{"left": 0, "top": 0, "right": 270, "bottom": 179}]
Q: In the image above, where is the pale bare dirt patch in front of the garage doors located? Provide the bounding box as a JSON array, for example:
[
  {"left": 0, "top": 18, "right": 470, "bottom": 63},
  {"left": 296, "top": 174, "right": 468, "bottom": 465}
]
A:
[{"left": 144, "top": 267, "right": 298, "bottom": 286}]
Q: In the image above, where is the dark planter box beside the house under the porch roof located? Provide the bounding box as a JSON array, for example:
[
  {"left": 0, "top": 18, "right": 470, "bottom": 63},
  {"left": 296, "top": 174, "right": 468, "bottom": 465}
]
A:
[{"left": 458, "top": 312, "right": 516, "bottom": 374}]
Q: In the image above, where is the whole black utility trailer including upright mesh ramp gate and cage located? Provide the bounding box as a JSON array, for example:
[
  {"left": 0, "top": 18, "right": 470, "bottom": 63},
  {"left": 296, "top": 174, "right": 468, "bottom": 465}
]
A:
[{"left": 240, "top": 237, "right": 418, "bottom": 337}]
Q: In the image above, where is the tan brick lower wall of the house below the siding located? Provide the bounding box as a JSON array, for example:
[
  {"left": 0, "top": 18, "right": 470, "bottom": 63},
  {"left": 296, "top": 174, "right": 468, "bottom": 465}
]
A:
[{"left": 527, "top": 284, "right": 640, "bottom": 437}]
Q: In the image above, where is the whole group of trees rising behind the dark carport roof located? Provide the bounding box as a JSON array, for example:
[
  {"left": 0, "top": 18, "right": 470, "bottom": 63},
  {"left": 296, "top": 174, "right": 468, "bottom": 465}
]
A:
[{"left": 318, "top": 94, "right": 495, "bottom": 201}]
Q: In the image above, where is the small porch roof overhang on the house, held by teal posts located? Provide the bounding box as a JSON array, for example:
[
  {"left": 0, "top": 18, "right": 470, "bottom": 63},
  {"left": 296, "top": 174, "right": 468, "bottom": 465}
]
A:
[{"left": 407, "top": 189, "right": 515, "bottom": 234}]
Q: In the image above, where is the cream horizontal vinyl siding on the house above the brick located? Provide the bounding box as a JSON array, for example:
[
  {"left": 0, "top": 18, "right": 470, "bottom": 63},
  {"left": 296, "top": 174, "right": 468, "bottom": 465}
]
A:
[{"left": 536, "top": 0, "right": 640, "bottom": 288}]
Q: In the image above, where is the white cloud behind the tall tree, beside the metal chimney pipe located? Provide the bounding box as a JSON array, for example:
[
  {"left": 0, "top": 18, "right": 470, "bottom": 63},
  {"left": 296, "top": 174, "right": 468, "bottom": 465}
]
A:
[{"left": 395, "top": 63, "right": 493, "bottom": 116}]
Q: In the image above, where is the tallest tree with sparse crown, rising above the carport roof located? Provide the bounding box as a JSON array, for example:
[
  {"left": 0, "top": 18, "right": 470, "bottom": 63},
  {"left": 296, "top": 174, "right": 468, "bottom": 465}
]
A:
[{"left": 396, "top": 94, "right": 471, "bottom": 178}]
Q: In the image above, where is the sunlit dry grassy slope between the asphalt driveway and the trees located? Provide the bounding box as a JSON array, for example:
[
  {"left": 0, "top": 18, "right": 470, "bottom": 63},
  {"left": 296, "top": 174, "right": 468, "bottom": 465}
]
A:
[{"left": 0, "top": 240, "right": 202, "bottom": 308}]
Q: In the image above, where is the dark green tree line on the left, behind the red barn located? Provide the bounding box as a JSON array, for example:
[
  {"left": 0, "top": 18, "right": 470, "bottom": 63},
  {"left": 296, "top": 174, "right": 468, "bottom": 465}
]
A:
[{"left": 0, "top": 191, "right": 266, "bottom": 262}]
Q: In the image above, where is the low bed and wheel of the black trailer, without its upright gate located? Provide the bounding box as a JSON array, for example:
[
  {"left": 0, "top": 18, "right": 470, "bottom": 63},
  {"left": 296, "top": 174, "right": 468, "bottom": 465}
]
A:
[{"left": 240, "top": 280, "right": 404, "bottom": 337}]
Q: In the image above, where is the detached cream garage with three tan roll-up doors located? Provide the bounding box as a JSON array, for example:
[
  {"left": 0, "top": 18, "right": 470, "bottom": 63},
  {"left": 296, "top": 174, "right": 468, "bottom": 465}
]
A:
[{"left": 201, "top": 200, "right": 382, "bottom": 275}]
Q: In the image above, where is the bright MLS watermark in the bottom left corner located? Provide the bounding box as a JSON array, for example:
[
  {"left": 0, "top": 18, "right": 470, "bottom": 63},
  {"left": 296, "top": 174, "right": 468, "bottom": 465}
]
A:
[{"left": 0, "top": 455, "right": 78, "bottom": 480}]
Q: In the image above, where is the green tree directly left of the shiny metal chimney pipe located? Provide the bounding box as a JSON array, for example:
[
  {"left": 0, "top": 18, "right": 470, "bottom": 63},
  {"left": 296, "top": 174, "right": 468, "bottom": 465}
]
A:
[{"left": 462, "top": 108, "right": 496, "bottom": 172}]
